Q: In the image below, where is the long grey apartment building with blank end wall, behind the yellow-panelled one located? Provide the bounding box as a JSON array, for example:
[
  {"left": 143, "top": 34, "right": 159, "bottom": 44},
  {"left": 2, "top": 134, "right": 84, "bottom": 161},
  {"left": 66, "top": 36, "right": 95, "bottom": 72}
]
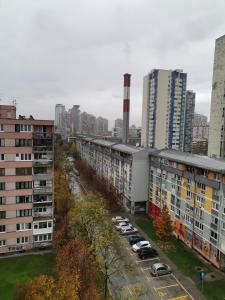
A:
[{"left": 76, "top": 137, "right": 148, "bottom": 213}]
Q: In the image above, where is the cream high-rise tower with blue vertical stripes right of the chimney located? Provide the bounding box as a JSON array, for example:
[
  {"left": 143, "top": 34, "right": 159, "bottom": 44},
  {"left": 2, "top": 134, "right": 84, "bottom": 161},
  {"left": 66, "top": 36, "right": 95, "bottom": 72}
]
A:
[{"left": 142, "top": 69, "right": 194, "bottom": 151}]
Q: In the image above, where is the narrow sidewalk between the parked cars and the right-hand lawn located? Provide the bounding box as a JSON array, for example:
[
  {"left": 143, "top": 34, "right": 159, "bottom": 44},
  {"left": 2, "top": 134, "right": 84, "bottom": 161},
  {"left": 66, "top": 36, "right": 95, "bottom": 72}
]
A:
[{"left": 123, "top": 213, "right": 206, "bottom": 300}]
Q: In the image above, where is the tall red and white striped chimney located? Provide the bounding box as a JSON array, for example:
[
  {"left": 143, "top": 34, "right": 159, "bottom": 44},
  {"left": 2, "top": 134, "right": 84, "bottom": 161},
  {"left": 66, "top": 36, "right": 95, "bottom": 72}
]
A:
[{"left": 122, "top": 73, "right": 131, "bottom": 144}]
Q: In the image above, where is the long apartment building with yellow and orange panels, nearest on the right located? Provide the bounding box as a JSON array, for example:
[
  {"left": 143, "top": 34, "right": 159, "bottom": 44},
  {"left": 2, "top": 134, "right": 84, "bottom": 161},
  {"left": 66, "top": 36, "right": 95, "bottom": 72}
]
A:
[{"left": 148, "top": 150, "right": 225, "bottom": 268}]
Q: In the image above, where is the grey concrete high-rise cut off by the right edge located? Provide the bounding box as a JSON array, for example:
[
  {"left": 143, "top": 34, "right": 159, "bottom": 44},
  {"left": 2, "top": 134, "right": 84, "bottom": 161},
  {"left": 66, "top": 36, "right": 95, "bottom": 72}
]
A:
[{"left": 208, "top": 35, "right": 225, "bottom": 158}]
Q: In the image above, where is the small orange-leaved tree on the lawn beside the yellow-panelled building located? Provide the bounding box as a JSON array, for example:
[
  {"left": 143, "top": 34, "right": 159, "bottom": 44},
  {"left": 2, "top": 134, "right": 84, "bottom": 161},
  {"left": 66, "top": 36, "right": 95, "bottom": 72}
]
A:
[{"left": 153, "top": 206, "right": 174, "bottom": 241}]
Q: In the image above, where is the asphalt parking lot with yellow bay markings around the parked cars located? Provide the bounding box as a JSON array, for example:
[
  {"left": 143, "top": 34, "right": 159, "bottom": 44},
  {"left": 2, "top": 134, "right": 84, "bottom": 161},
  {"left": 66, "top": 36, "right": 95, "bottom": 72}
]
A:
[{"left": 116, "top": 225, "right": 195, "bottom": 300}]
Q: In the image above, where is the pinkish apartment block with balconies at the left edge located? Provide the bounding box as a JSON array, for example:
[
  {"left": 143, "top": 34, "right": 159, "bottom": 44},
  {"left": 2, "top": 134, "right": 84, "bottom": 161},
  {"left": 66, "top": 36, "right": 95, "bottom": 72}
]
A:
[{"left": 0, "top": 105, "right": 54, "bottom": 254}]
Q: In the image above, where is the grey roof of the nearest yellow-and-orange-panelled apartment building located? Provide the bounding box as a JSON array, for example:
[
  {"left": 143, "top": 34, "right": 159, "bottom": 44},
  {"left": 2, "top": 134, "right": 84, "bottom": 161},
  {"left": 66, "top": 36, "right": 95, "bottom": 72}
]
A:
[{"left": 150, "top": 150, "right": 225, "bottom": 173}]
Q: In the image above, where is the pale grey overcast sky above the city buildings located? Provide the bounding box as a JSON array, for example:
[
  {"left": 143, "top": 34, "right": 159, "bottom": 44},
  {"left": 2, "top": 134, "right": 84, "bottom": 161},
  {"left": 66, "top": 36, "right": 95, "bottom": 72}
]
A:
[{"left": 0, "top": 0, "right": 225, "bottom": 125}]
